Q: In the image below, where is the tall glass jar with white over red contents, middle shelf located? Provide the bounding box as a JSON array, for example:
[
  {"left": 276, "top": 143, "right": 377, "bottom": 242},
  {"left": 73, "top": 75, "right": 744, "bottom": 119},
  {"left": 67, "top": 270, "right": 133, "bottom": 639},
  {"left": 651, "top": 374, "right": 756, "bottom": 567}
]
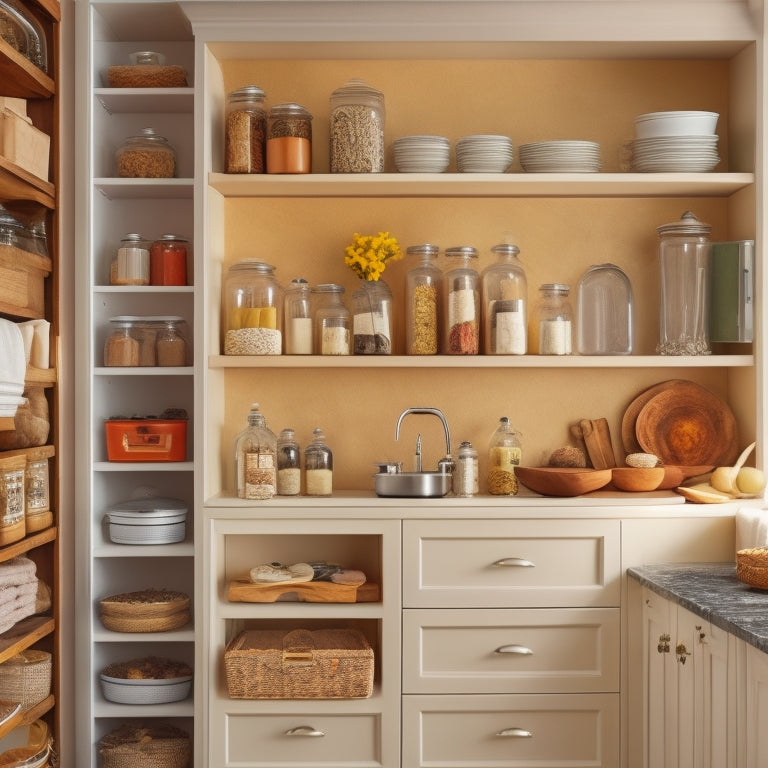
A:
[{"left": 443, "top": 246, "right": 480, "bottom": 355}]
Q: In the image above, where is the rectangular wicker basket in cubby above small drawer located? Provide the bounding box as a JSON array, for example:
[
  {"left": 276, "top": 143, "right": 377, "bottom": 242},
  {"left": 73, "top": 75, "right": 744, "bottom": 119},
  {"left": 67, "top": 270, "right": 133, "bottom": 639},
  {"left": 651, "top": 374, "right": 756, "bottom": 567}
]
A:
[{"left": 224, "top": 629, "right": 374, "bottom": 699}]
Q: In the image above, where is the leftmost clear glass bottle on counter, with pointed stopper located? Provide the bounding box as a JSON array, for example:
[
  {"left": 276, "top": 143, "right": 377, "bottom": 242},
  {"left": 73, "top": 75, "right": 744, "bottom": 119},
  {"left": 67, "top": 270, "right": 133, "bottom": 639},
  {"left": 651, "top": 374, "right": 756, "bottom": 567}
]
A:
[{"left": 235, "top": 403, "right": 277, "bottom": 499}]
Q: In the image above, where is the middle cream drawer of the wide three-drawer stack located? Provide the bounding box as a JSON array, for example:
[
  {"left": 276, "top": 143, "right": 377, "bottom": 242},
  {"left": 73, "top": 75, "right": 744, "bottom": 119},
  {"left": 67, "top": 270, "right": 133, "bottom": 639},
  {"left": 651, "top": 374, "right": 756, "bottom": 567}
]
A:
[{"left": 403, "top": 608, "right": 620, "bottom": 693}]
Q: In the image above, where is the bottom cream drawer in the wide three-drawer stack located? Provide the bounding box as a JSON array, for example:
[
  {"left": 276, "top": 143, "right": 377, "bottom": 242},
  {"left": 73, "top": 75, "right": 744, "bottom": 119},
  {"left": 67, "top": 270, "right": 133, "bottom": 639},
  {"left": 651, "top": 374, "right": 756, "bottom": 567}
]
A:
[{"left": 403, "top": 693, "right": 619, "bottom": 768}]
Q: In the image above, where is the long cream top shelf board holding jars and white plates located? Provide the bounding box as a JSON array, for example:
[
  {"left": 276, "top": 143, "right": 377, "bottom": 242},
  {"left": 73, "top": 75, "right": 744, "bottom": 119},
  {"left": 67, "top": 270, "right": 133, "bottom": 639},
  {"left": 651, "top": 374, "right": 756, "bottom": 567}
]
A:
[{"left": 209, "top": 173, "right": 755, "bottom": 197}]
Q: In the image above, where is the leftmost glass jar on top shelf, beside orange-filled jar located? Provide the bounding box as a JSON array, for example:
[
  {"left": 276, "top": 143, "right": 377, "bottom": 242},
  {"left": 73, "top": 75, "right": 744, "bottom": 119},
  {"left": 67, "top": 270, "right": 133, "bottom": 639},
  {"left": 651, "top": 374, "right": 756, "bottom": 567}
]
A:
[{"left": 224, "top": 85, "right": 267, "bottom": 173}]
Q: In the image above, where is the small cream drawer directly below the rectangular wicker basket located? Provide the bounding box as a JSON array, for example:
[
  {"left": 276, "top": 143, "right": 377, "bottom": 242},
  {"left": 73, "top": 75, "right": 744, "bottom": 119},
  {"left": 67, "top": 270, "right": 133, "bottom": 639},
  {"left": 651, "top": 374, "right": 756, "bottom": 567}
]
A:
[{"left": 224, "top": 713, "right": 381, "bottom": 768}]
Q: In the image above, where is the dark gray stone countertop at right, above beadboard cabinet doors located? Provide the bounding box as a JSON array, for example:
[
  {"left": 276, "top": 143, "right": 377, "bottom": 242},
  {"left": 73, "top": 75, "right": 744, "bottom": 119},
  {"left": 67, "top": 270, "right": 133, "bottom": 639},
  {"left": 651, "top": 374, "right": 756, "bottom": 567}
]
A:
[{"left": 627, "top": 563, "right": 768, "bottom": 653}]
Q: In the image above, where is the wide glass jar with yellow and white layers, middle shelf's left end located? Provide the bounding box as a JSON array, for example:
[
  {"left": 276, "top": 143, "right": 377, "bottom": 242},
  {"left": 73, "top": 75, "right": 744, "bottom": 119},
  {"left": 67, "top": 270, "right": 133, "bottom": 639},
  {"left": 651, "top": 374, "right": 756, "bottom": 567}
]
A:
[{"left": 224, "top": 259, "right": 283, "bottom": 355}]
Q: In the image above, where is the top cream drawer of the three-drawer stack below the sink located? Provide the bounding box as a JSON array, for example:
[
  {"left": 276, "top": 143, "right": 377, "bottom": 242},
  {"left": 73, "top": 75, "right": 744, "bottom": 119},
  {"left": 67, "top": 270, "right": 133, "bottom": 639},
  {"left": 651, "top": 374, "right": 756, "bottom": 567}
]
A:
[{"left": 403, "top": 520, "right": 621, "bottom": 608}]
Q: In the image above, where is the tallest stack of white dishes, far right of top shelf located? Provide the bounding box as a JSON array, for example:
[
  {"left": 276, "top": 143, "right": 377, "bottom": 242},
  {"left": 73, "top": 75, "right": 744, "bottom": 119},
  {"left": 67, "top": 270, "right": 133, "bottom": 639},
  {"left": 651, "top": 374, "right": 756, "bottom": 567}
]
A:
[{"left": 632, "top": 111, "right": 720, "bottom": 173}]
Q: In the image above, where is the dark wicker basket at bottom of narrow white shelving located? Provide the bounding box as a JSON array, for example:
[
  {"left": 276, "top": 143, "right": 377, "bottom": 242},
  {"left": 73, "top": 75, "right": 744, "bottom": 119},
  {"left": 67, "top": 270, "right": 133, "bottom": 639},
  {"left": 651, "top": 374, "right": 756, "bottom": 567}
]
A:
[{"left": 99, "top": 723, "right": 192, "bottom": 768}]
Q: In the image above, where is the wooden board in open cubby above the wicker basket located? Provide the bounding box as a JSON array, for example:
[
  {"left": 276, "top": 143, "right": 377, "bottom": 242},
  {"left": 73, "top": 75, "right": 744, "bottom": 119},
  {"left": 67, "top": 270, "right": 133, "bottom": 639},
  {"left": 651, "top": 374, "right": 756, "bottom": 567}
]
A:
[{"left": 227, "top": 578, "right": 380, "bottom": 603}]
